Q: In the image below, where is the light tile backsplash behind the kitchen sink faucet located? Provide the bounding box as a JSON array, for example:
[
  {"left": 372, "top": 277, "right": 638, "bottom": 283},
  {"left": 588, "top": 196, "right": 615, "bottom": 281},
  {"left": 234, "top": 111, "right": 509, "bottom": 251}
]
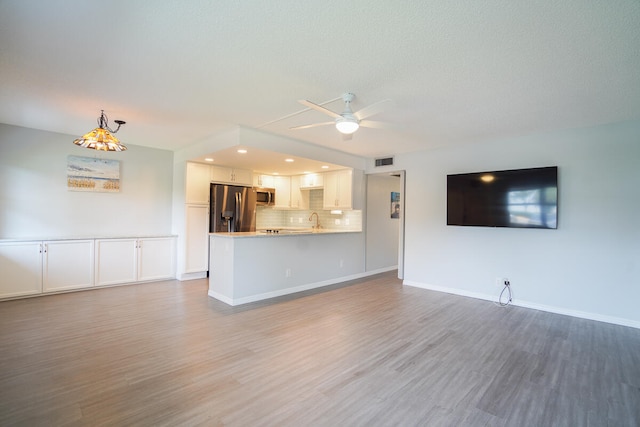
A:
[{"left": 256, "top": 190, "right": 362, "bottom": 231}]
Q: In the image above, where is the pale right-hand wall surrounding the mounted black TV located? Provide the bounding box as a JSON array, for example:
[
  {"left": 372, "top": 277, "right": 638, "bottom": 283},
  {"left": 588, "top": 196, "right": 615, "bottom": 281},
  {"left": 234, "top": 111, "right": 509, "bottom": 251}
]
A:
[{"left": 394, "top": 122, "right": 640, "bottom": 327}]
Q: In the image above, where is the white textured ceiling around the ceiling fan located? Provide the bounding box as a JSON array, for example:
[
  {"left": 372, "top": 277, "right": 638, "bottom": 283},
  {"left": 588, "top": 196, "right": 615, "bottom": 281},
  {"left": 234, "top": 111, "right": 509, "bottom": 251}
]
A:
[{"left": 0, "top": 0, "right": 640, "bottom": 162}]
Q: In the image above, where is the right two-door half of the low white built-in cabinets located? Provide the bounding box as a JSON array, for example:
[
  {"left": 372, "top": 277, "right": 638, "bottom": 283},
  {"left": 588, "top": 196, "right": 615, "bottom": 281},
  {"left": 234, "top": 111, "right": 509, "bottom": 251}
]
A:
[{"left": 95, "top": 237, "right": 175, "bottom": 286}]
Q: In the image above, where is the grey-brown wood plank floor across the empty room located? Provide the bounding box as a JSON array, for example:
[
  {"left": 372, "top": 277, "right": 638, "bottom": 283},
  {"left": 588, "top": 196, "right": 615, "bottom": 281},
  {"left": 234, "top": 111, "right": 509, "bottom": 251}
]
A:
[{"left": 0, "top": 272, "right": 640, "bottom": 427}]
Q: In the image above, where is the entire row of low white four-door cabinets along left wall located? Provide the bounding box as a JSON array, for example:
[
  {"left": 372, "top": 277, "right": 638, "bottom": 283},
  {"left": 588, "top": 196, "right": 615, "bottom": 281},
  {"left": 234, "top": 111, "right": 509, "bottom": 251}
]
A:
[{"left": 0, "top": 237, "right": 175, "bottom": 298}]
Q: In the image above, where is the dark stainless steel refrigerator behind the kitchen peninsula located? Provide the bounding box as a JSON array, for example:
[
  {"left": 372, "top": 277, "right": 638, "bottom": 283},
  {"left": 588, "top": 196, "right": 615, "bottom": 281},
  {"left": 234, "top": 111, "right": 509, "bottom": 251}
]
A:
[{"left": 209, "top": 184, "right": 256, "bottom": 233}]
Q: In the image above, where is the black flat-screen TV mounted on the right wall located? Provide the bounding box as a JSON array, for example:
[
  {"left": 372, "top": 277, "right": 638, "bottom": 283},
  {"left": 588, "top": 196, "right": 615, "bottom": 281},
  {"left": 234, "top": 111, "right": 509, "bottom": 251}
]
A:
[{"left": 447, "top": 166, "right": 558, "bottom": 229}]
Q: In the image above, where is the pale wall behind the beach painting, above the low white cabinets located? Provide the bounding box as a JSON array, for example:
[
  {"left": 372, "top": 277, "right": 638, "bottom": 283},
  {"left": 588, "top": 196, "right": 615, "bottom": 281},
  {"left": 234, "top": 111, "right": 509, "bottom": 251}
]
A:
[{"left": 0, "top": 124, "right": 173, "bottom": 239}]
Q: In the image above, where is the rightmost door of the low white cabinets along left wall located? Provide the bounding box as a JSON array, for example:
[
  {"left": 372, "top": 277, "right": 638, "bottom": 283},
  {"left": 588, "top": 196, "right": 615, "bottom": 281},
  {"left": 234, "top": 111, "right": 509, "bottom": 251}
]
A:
[{"left": 138, "top": 237, "right": 176, "bottom": 281}]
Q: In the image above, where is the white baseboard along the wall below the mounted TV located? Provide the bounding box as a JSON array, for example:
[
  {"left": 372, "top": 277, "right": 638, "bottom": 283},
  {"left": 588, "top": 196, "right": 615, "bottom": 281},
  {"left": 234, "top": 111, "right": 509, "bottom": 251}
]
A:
[{"left": 402, "top": 280, "right": 640, "bottom": 329}]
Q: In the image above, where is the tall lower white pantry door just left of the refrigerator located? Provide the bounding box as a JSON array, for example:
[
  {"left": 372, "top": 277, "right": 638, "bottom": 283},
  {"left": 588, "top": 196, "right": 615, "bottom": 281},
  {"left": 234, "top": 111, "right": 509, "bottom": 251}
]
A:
[{"left": 184, "top": 205, "right": 209, "bottom": 273}]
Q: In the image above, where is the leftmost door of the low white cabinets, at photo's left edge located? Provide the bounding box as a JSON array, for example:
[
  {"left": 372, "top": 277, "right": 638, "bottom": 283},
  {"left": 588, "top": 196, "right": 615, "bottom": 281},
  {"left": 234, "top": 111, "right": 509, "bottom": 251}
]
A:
[{"left": 0, "top": 242, "right": 42, "bottom": 298}]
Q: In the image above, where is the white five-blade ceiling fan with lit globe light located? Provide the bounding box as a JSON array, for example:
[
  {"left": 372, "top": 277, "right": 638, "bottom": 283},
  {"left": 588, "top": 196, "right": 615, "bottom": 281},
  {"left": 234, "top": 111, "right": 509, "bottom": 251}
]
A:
[{"left": 290, "top": 93, "right": 396, "bottom": 139}]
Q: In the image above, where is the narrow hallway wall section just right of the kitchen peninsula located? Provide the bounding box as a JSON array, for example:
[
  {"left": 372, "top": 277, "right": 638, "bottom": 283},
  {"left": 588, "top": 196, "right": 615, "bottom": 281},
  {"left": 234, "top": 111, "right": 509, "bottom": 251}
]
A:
[{"left": 366, "top": 174, "right": 404, "bottom": 271}]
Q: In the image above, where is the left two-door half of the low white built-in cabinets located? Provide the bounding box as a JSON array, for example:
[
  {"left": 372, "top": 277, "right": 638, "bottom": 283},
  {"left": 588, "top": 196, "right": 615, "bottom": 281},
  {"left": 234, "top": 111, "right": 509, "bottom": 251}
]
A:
[{"left": 0, "top": 240, "right": 94, "bottom": 298}]
